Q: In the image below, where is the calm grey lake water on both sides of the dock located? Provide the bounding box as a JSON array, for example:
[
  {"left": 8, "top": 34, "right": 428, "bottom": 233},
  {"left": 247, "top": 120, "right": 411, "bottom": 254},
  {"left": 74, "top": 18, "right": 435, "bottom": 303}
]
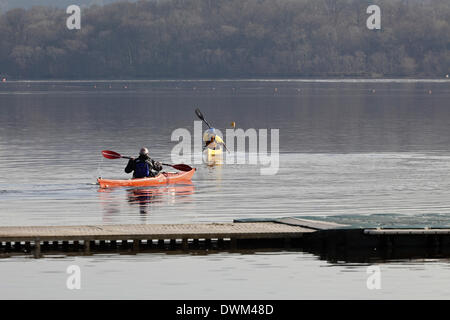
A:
[{"left": 0, "top": 80, "right": 450, "bottom": 298}]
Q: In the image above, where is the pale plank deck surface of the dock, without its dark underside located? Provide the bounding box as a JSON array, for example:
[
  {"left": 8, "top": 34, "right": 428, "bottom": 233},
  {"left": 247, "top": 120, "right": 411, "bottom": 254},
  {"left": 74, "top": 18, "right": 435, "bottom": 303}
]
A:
[{"left": 0, "top": 222, "right": 315, "bottom": 242}]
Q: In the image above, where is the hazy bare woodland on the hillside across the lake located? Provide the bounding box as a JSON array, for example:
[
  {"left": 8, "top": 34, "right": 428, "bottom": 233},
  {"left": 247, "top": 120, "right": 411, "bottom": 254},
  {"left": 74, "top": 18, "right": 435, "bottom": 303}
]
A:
[{"left": 0, "top": 0, "right": 450, "bottom": 79}]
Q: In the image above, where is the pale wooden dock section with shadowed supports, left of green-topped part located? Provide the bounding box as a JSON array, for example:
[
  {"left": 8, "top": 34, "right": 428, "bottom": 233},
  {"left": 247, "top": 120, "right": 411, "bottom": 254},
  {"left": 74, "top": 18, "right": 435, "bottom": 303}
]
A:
[{"left": 0, "top": 222, "right": 314, "bottom": 257}]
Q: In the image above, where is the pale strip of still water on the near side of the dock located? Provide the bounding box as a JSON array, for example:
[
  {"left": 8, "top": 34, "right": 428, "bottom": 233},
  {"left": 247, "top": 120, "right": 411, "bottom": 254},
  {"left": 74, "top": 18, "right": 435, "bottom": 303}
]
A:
[{"left": 0, "top": 251, "right": 450, "bottom": 299}]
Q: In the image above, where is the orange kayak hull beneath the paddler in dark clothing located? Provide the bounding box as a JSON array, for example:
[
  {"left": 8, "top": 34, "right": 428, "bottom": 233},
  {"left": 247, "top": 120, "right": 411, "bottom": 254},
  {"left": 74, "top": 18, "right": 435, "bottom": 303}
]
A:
[{"left": 97, "top": 169, "right": 195, "bottom": 188}]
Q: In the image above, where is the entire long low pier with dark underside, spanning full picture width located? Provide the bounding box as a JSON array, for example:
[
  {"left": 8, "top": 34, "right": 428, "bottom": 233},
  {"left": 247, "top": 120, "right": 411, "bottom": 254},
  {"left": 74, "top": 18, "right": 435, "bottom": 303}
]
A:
[{"left": 0, "top": 217, "right": 450, "bottom": 261}]
